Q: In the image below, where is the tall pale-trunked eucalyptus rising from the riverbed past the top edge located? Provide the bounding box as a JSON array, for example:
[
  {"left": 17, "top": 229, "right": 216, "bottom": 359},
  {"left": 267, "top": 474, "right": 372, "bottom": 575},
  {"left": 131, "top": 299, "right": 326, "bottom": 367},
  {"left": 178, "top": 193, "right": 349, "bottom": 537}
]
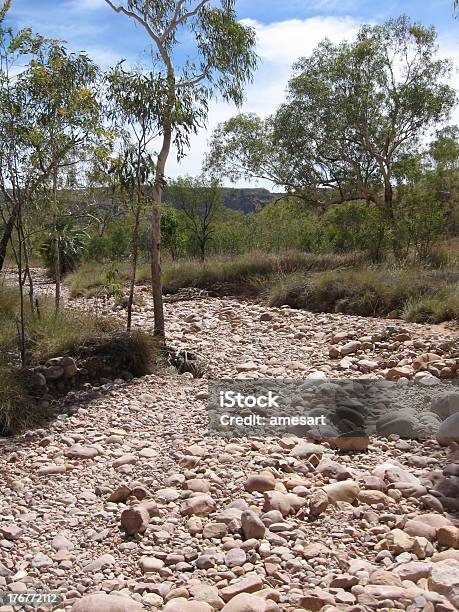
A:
[{"left": 105, "top": 0, "right": 257, "bottom": 337}]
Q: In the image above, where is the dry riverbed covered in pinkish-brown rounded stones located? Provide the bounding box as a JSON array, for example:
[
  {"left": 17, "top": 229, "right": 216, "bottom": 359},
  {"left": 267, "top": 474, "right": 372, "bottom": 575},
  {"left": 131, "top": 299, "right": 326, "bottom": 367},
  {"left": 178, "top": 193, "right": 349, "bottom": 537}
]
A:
[{"left": 0, "top": 278, "right": 459, "bottom": 612}]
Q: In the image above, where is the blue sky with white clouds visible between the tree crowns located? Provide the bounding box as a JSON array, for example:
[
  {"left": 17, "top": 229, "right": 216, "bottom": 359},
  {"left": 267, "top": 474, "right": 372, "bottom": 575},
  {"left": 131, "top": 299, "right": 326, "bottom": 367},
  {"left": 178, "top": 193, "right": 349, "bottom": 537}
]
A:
[{"left": 5, "top": 0, "right": 459, "bottom": 186}]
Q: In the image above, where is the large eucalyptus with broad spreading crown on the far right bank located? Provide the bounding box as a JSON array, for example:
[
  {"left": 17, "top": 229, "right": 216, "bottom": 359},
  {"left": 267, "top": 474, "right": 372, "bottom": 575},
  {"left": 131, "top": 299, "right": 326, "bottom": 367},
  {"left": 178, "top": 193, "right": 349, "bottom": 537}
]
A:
[{"left": 209, "top": 17, "right": 456, "bottom": 251}]
